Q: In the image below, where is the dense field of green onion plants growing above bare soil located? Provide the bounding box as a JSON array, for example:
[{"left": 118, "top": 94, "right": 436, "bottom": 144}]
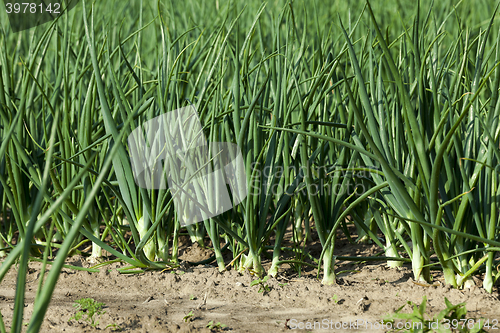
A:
[{"left": 0, "top": 0, "right": 500, "bottom": 333}]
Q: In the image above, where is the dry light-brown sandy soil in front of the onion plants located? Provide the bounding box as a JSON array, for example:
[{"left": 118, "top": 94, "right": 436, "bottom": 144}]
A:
[{"left": 0, "top": 233, "right": 500, "bottom": 333}]
